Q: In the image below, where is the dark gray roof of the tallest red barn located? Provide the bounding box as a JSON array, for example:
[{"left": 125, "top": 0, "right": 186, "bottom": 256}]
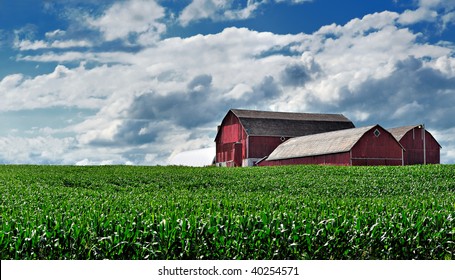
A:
[{"left": 221, "top": 109, "right": 354, "bottom": 137}]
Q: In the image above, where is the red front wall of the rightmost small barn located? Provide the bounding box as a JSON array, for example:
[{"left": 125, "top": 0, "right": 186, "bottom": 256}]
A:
[{"left": 400, "top": 128, "right": 440, "bottom": 165}]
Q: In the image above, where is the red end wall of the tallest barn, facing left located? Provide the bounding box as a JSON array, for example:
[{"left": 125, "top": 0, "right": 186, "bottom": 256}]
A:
[{"left": 215, "top": 113, "right": 246, "bottom": 166}]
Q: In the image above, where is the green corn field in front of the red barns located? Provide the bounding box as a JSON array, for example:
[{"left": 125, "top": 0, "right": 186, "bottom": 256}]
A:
[{"left": 0, "top": 165, "right": 455, "bottom": 260}]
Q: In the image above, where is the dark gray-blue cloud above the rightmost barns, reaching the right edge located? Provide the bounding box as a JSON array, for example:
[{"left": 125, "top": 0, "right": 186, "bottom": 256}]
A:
[{"left": 319, "top": 57, "right": 455, "bottom": 129}]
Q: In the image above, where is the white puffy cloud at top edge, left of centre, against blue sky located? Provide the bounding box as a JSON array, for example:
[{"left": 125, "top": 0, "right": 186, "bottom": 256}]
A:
[{"left": 87, "top": 0, "right": 166, "bottom": 43}]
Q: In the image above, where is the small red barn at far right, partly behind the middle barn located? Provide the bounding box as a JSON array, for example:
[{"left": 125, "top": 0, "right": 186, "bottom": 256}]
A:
[{"left": 389, "top": 125, "right": 441, "bottom": 165}]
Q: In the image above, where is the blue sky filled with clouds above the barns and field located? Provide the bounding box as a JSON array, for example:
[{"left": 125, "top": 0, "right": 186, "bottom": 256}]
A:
[{"left": 0, "top": 0, "right": 455, "bottom": 165}]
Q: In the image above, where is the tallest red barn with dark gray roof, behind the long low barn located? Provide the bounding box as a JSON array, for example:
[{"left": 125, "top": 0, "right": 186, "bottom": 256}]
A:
[{"left": 215, "top": 109, "right": 354, "bottom": 166}]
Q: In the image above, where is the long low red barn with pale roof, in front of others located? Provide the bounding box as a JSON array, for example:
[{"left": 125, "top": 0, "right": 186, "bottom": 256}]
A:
[{"left": 258, "top": 125, "right": 403, "bottom": 166}]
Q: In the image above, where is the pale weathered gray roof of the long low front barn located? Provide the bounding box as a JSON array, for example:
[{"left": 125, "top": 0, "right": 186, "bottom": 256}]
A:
[{"left": 266, "top": 125, "right": 380, "bottom": 160}]
